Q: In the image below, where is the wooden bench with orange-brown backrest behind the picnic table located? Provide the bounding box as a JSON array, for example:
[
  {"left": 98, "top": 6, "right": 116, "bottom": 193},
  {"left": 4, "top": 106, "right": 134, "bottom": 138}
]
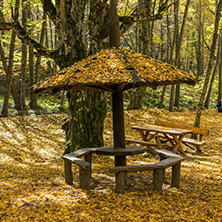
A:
[{"left": 155, "top": 120, "right": 209, "bottom": 152}]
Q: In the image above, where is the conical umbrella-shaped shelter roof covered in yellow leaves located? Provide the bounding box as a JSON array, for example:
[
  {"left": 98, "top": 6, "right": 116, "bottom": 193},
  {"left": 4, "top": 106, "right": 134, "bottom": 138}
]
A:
[{"left": 33, "top": 48, "right": 197, "bottom": 92}]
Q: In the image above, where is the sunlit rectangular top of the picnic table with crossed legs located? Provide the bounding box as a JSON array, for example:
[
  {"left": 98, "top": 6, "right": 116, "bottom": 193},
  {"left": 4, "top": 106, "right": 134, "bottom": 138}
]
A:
[{"left": 131, "top": 125, "right": 193, "bottom": 135}]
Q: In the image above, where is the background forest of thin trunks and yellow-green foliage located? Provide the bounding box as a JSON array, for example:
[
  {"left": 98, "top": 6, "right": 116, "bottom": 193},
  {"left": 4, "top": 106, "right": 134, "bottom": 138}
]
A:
[{"left": 0, "top": 0, "right": 222, "bottom": 116}]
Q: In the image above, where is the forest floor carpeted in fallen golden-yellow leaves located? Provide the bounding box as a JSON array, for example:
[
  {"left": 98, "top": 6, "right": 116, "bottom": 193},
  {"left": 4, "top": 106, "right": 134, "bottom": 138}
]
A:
[{"left": 0, "top": 110, "right": 222, "bottom": 222}]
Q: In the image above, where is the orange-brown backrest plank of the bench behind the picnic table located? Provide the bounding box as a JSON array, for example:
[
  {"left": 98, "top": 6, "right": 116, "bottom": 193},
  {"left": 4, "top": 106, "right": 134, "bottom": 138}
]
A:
[{"left": 155, "top": 120, "right": 209, "bottom": 135}]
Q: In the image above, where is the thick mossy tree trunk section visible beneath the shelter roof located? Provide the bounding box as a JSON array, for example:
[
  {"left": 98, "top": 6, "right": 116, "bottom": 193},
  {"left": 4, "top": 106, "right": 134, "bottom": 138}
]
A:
[{"left": 65, "top": 91, "right": 107, "bottom": 153}]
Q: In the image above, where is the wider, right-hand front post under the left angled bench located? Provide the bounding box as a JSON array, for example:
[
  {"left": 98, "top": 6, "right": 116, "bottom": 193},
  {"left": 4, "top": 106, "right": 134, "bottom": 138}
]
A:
[{"left": 79, "top": 166, "right": 91, "bottom": 190}]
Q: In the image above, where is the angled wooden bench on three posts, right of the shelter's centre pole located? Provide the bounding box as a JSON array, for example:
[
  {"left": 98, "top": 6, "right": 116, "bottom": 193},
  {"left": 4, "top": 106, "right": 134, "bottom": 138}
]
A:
[{"left": 109, "top": 149, "right": 184, "bottom": 193}]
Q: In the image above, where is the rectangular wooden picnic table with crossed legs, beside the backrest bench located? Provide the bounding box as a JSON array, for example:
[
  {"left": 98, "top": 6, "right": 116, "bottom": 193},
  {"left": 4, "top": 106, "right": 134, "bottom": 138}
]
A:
[{"left": 131, "top": 125, "right": 193, "bottom": 154}]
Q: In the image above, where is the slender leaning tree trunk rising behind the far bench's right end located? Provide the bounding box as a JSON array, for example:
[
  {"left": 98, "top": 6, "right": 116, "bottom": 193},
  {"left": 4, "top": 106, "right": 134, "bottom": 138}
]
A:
[{"left": 194, "top": 0, "right": 222, "bottom": 127}]
